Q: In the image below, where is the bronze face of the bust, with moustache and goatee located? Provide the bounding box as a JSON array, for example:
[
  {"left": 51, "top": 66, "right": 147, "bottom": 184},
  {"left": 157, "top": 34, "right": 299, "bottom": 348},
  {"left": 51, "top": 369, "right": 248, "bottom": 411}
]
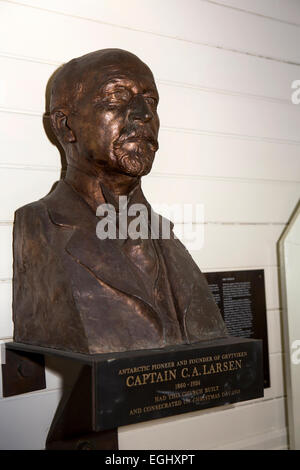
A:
[{"left": 69, "top": 56, "right": 159, "bottom": 176}]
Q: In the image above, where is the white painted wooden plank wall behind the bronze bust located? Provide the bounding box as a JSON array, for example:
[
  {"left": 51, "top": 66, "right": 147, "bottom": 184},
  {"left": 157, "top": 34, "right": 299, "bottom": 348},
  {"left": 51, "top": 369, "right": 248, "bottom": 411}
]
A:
[{"left": 0, "top": 0, "right": 300, "bottom": 449}]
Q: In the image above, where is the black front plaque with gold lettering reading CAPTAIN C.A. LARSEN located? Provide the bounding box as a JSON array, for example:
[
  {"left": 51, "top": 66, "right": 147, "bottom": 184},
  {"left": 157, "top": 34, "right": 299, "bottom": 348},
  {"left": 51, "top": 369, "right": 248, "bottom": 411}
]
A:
[{"left": 95, "top": 338, "right": 263, "bottom": 430}]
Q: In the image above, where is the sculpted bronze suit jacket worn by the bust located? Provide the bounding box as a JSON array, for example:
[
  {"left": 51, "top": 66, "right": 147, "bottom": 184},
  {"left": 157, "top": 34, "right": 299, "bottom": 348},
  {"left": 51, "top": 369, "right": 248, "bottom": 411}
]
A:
[{"left": 13, "top": 181, "right": 227, "bottom": 354}]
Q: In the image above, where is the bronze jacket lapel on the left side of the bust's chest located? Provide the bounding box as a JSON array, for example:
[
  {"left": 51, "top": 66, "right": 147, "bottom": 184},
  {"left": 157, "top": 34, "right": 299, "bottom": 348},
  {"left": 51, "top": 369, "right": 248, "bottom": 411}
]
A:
[{"left": 44, "top": 181, "right": 155, "bottom": 310}]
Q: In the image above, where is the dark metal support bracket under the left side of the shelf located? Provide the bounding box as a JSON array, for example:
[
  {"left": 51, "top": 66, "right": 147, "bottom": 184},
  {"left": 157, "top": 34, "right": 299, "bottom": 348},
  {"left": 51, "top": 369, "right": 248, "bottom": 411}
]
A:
[{"left": 1, "top": 342, "right": 118, "bottom": 450}]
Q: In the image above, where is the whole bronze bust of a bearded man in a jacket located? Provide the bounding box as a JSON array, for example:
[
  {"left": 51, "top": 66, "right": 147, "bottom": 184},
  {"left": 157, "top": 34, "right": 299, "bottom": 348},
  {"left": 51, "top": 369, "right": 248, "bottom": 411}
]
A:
[{"left": 13, "top": 49, "right": 227, "bottom": 354}]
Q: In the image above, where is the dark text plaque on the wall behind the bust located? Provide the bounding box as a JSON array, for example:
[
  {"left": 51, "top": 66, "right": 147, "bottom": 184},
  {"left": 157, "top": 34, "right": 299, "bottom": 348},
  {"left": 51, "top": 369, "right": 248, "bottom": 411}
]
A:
[{"left": 204, "top": 269, "right": 270, "bottom": 388}]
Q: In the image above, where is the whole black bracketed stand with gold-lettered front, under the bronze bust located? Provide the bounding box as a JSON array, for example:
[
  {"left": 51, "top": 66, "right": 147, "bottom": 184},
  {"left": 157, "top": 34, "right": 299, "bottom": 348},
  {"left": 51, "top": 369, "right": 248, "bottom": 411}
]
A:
[{"left": 3, "top": 337, "right": 263, "bottom": 449}]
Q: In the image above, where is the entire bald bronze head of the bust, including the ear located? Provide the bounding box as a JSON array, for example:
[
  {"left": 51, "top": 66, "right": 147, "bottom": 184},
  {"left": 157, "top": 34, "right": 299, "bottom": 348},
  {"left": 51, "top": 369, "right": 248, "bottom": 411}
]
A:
[{"left": 50, "top": 49, "right": 159, "bottom": 177}]
